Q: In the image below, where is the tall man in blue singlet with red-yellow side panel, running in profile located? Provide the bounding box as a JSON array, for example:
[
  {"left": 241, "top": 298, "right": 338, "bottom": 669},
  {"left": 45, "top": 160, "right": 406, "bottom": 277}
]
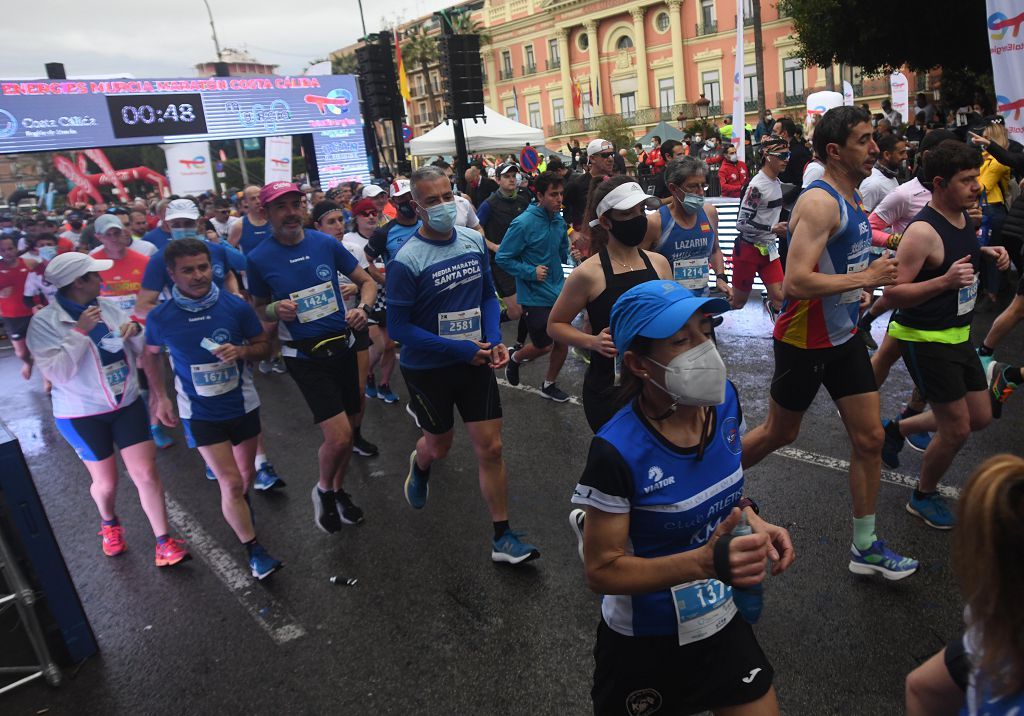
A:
[{"left": 743, "top": 107, "right": 919, "bottom": 580}]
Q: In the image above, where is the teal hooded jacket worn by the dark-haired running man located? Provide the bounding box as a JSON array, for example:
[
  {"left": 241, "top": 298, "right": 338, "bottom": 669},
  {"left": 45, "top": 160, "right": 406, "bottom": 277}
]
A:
[{"left": 495, "top": 203, "right": 569, "bottom": 306}]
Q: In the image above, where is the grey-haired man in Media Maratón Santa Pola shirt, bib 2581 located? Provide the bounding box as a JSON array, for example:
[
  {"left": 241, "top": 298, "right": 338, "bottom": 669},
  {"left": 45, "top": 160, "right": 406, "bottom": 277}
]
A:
[{"left": 387, "top": 167, "right": 541, "bottom": 564}]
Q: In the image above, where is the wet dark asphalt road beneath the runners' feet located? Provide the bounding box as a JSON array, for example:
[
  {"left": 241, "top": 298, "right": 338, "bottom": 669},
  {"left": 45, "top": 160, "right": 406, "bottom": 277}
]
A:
[{"left": 0, "top": 304, "right": 1024, "bottom": 716}]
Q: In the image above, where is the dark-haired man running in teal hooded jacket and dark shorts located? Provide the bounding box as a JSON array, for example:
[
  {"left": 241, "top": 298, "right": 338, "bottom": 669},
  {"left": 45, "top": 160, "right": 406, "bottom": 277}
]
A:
[{"left": 495, "top": 173, "right": 569, "bottom": 403}]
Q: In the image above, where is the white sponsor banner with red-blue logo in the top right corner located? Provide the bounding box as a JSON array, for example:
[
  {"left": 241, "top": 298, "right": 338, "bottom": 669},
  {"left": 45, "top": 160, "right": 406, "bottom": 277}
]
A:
[{"left": 983, "top": 0, "right": 1024, "bottom": 142}]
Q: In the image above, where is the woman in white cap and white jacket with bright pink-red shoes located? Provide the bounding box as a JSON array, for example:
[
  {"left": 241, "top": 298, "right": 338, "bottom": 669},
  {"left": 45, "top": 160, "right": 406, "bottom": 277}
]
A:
[{"left": 28, "top": 252, "right": 188, "bottom": 566}]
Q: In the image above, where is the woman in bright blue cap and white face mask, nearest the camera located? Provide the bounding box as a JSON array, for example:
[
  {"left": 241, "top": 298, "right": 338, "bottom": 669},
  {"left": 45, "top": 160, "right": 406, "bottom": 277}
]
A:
[{"left": 572, "top": 281, "right": 795, "bottom": 715}]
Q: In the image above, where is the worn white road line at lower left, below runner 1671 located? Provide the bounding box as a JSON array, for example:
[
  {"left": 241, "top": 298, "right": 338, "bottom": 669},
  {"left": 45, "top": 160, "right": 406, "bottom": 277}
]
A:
[{"left": 165, "top": 495, "right": 306, "bottom": 646}]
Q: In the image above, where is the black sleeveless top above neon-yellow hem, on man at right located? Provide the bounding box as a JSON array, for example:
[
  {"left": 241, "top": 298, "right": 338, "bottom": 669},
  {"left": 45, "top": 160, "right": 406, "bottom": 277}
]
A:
[{"left": 895, "top": 206, "right": 981, "bottom": 331}]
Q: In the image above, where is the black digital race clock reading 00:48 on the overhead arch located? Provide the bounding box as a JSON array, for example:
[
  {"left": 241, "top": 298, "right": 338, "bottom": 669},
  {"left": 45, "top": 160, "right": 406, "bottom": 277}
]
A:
[{"left": 106, "top": 92, "right": 206, "bottom": 139}]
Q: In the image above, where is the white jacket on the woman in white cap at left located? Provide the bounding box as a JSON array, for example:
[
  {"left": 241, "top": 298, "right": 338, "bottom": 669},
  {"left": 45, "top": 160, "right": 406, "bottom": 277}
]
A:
[{"left": 27, "top": 298, "right": 145, "bottom": 418}]
